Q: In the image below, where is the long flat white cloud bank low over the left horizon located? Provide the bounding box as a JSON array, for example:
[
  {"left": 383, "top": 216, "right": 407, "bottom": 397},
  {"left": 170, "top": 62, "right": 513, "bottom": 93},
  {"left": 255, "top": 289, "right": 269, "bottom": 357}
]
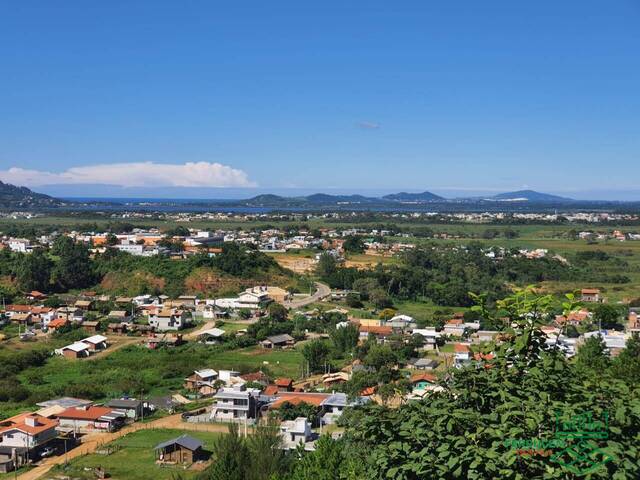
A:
[{"left": 0, "top": 162, "right": 255, "bottom": 187}]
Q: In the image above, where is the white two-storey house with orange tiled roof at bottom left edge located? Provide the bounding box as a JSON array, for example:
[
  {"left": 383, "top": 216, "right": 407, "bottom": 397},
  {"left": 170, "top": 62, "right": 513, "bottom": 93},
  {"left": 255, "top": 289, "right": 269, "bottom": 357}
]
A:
[{"left": 0, "top": 413, "right": 58, "bottom": 453}]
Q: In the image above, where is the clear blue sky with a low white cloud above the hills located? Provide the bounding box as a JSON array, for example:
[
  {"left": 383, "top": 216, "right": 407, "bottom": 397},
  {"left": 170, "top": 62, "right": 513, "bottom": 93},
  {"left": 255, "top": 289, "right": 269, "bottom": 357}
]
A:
[{"left": 0, "top": 0, "right": 640, "bottom": 199}]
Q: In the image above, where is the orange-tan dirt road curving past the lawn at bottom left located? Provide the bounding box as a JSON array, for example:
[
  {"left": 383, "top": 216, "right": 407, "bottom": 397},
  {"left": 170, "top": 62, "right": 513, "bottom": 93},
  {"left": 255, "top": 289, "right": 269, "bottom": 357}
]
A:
[{"left": 18, "top": 413, "right": 229, "bottom": 480}]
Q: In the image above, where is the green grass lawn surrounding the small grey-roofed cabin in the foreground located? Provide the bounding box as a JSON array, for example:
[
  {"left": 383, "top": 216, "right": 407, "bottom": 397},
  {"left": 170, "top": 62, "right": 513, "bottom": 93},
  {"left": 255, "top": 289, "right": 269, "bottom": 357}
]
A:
[{"left": 51, "top": 429, "right": 220, "bottom": 480}]
